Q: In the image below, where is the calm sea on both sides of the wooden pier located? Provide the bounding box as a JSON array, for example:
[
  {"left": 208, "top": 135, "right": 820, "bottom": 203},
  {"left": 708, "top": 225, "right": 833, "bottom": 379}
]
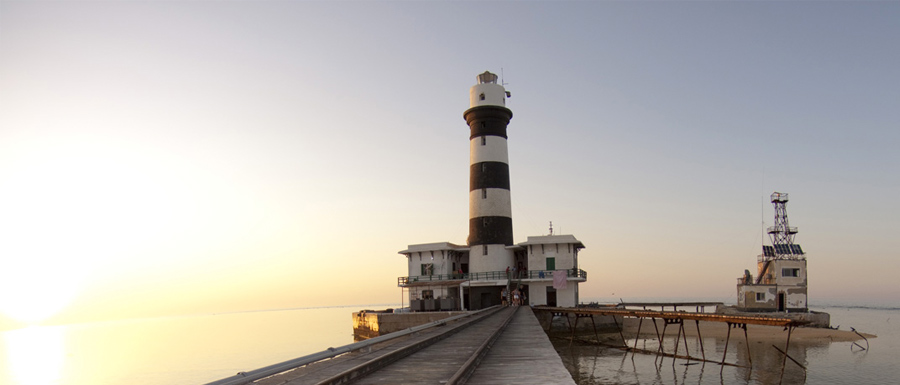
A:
[{"left": 0, "top": 305, "right": 900, "bottom": 385}]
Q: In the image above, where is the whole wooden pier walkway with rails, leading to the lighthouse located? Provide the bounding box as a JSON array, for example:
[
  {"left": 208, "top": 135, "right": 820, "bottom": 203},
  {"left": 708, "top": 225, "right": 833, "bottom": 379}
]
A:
[{"left": 253, "top": 306, "right": 575, "bottom": 385}]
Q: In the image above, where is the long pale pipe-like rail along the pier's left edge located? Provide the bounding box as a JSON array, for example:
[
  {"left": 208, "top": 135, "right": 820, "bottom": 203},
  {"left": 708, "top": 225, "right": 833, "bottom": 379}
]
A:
[{"left": 206, "top": 306, "right": 497, "bottom": 385}]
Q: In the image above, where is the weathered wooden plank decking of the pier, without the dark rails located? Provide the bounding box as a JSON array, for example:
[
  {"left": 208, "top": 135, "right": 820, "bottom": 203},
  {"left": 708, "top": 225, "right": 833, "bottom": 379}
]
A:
[{"left": 255, "top": 306, "right": 575, "bottom": 385}]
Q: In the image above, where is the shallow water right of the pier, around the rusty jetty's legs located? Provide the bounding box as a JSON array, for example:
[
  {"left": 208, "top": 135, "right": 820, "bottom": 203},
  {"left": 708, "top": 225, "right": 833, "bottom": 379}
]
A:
[{"left": 553, "top": 307, "right": 900, "bottom": 385}]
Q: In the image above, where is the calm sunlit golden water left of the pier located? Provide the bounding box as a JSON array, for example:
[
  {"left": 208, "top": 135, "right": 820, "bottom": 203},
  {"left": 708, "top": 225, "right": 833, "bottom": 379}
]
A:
[{"left": 0, "top": 306, "right": 360, "bottom": 385}]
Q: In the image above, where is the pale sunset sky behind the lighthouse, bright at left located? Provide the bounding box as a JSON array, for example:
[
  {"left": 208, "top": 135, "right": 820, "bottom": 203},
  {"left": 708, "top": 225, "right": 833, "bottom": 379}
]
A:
[{"left": 0, "top": 1, "right": 900, "bottom": 328}]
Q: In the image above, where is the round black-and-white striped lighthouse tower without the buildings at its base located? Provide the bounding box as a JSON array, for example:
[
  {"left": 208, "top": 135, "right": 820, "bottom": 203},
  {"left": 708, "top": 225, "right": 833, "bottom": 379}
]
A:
[{"left": 463, "top": 71, "right": 514, "bottom": 272}]
